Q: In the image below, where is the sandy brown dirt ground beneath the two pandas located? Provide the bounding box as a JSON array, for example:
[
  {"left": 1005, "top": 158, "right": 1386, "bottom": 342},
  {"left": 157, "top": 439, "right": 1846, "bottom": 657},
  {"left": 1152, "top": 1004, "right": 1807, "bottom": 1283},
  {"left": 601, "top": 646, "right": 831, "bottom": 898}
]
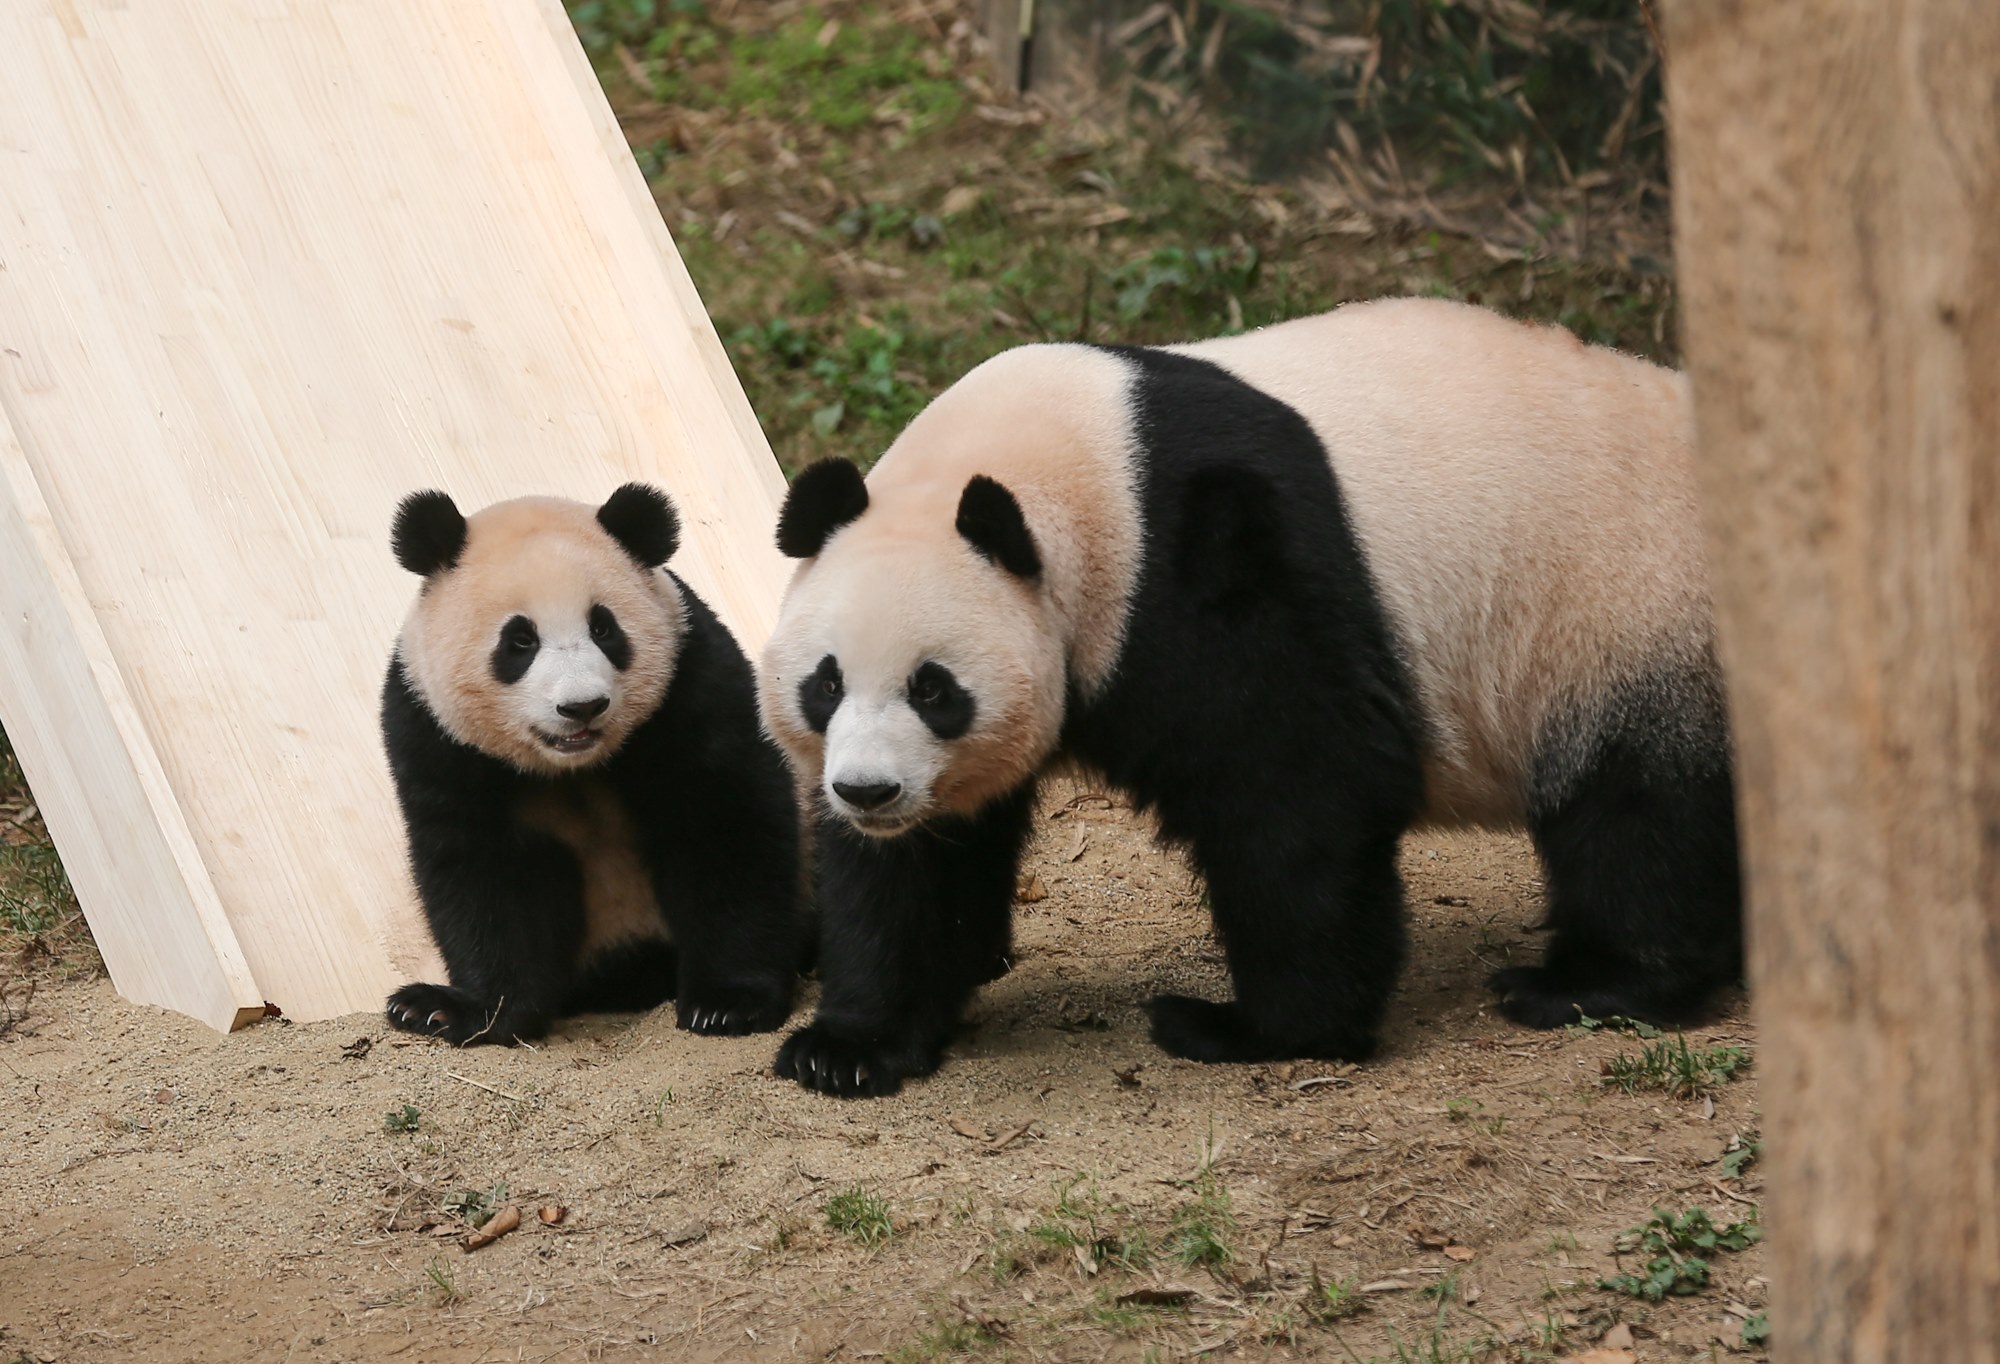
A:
[{"left": 0, "top": 786, "right": 1764, "bottom": 1364}]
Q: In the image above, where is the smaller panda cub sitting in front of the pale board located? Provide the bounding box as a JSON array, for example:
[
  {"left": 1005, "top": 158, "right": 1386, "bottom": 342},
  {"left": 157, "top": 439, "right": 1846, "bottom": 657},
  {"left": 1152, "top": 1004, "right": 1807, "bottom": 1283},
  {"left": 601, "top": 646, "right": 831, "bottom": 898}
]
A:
[{"left": 382, "top": 484, "right": 804, "bottom": 1044}]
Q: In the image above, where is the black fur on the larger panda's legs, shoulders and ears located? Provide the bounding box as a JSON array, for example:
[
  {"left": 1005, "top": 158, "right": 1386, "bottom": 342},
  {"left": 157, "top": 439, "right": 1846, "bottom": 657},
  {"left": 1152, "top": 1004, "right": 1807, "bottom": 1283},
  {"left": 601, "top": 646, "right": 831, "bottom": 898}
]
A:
[{"left": 764, "top": 298, "right": 1742, "bottom": 1096}]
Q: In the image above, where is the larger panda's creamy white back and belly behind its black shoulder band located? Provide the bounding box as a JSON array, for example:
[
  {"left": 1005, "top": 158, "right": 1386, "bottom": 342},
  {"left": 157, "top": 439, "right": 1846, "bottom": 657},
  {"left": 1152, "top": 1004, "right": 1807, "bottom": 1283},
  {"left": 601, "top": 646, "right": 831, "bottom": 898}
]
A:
[{"left": 1172, "top": 298, "right": 1710, "bottom": 826}]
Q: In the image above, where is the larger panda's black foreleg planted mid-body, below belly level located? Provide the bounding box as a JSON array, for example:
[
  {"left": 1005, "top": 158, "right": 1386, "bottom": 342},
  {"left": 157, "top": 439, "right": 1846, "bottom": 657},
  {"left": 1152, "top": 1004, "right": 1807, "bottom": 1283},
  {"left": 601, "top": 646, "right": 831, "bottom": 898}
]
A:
[{"left": 1150, "top": 818, "right": 1404, "bottom": 1062}]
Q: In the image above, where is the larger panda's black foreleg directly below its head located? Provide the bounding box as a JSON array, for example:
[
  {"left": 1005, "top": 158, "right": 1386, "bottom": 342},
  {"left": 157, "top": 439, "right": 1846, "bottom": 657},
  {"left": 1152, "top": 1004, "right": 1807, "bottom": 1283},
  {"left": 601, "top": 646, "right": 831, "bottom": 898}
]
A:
[{"left": 776, "top": 784, "right": 1034, "bottom": 1098}]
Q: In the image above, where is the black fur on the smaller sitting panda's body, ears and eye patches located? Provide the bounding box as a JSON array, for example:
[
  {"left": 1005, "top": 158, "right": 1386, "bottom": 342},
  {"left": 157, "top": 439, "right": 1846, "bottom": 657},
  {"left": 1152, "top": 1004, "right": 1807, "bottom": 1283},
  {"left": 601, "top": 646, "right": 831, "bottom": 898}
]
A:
[{"left": 382, "top": 484, "right": 808, "bottom": 1044}]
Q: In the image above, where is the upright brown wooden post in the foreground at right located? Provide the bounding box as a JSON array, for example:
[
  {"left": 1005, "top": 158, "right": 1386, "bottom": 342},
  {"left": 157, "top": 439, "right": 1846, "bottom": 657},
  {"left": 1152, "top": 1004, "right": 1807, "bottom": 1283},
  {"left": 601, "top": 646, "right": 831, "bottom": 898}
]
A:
[{"left": 1664, "top": 0, "right": 2000, "bottom": 1364}]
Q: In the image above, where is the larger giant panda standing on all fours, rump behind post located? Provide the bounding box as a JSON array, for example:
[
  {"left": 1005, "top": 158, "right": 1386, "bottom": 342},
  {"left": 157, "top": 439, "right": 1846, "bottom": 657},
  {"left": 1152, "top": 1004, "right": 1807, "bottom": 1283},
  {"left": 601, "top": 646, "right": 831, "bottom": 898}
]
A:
[{"left": 760, "top": 298, "right": 1742, "bottom": 1096}]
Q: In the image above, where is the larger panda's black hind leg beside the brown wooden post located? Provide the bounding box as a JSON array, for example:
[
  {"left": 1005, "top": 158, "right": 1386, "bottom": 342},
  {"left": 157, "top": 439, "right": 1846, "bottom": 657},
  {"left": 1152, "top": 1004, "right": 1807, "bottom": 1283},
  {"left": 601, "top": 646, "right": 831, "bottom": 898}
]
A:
[{"left": 1492, "top": 708, "right": 1742, "bottom": 1028}]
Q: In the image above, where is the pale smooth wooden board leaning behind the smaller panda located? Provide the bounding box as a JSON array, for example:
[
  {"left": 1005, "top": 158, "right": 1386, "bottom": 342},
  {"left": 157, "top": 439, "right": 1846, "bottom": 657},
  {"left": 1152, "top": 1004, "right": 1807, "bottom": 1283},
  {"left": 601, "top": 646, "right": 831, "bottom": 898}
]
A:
[{"left": 0, "top": 0, "right": 786, "bottom": 1028}]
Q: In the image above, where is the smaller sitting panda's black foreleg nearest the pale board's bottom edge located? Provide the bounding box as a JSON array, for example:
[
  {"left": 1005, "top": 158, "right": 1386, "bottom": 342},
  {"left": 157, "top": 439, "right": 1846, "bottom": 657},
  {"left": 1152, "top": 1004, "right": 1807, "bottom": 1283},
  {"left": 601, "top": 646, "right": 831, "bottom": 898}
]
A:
[{"left": 384, "top": 824, "right": 584, "bottom": 1046}]
